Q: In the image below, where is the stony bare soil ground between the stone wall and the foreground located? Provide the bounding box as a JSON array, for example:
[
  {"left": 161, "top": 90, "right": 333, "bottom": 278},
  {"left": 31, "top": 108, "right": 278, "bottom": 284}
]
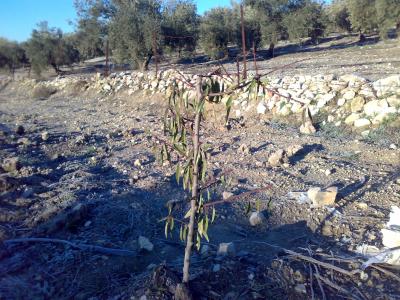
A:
[{"left": 0, "top": 38, "right": 400, "bottom": 300}]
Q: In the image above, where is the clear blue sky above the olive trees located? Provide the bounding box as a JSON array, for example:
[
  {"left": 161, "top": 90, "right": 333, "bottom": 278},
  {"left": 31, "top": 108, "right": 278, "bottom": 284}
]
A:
[{"left": 0, "top": 0, "right": 234, "bottom": 41}]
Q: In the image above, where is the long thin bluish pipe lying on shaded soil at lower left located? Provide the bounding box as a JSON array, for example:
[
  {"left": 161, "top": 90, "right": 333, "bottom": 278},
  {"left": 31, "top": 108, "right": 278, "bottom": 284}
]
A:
[{"left": 4, "top": 238, "right": 136, "bottom": 256}]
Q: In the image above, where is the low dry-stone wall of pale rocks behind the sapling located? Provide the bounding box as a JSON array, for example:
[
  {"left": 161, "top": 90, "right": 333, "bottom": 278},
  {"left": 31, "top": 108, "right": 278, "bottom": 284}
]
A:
[{"left": 15, "top": 70, "right": 400, "bottom": 129}]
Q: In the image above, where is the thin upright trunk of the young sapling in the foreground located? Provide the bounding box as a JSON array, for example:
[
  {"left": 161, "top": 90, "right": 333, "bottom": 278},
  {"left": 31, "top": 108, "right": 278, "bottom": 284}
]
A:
[{"left": 176, "top": 77, "right": 205, "bottom": 300}]
